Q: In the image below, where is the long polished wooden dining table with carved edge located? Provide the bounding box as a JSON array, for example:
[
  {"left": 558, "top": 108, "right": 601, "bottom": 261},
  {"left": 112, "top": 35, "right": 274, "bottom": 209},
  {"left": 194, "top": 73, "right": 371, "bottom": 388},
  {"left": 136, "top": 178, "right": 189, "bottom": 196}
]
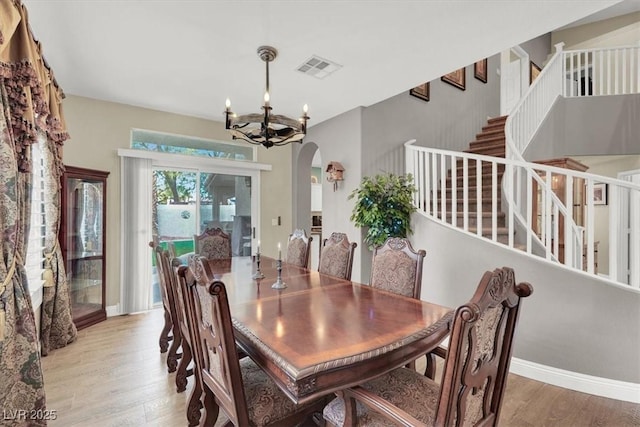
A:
[{"left": 204, "top": 257, "right": 453, "bottom": 403}]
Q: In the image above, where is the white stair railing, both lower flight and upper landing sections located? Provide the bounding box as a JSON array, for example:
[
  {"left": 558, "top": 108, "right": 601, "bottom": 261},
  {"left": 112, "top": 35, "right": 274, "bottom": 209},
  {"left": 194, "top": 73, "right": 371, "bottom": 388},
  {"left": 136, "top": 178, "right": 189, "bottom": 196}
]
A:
[{"left": 405, "top": 44, "right": 640, "bottom": 288}]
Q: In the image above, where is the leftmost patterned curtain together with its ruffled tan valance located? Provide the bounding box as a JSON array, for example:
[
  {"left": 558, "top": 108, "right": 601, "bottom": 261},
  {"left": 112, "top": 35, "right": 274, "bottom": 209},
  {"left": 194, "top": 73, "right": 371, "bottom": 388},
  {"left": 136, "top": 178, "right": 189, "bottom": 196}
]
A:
[{"left": 0, "top": 0, "right": 73, "bottom": 426}]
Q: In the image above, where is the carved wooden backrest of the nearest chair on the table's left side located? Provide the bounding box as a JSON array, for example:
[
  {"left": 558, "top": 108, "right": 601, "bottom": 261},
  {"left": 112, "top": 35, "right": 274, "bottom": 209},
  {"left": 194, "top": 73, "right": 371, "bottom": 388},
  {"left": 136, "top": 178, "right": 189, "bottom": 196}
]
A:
[{"left": 181, "top": 256, "right": 250, "bottom": 426}]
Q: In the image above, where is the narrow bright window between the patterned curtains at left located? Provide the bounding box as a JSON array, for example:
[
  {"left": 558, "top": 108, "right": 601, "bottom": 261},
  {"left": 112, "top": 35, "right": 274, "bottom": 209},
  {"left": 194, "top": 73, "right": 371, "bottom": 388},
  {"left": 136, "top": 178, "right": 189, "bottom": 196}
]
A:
[{"left": 25, "top": 135, "right": 46, "bottom": 310}]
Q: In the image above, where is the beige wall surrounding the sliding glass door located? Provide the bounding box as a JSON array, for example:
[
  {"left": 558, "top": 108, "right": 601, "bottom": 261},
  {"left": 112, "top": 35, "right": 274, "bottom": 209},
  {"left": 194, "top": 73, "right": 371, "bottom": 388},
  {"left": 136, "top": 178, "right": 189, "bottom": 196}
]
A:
[{"left": 63, "top": 96, "right": 291, "bottom": 306}]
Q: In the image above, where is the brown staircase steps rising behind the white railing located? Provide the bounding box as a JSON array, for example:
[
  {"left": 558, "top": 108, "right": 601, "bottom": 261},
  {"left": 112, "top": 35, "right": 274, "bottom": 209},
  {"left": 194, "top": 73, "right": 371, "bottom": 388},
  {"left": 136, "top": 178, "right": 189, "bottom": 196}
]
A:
[{"left": 440, "top": 116, "right": 508, "bottom": 244}]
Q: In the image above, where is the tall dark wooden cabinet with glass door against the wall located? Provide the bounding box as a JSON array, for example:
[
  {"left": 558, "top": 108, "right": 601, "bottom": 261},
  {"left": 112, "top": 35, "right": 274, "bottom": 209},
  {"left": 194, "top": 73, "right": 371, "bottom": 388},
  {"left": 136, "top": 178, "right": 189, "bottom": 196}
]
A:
[{"left": 59, "top": 166, "right": 109, "bottom": 329}]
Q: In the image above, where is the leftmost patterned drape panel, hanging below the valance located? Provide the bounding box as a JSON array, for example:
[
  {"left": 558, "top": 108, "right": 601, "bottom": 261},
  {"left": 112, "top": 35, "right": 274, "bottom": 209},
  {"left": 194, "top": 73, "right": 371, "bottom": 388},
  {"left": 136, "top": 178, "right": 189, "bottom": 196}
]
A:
[{"left": 0, "top": 80, "right": 46, "bottom": 426}]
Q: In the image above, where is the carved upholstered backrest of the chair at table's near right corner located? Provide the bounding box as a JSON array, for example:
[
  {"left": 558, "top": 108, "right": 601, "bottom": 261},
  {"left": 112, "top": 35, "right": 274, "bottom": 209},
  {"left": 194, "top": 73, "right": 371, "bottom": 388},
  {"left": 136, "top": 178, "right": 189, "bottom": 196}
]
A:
[{"left": 435, "top": 267, "right": 533, "bottom": 426}]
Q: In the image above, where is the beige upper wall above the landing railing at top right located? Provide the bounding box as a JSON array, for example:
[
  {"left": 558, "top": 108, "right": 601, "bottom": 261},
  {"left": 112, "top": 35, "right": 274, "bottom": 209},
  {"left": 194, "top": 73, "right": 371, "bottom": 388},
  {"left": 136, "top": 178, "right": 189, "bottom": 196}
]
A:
[{"left": 551, "top": 12, "right": 640, "bottom": 50}]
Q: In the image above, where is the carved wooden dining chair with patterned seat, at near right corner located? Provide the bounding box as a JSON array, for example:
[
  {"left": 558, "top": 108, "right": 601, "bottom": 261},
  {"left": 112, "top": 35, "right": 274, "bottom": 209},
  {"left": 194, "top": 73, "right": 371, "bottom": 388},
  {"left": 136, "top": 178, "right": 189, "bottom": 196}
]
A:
[{"left": 323, "top": 267, "right": 533, "bottom": 426}]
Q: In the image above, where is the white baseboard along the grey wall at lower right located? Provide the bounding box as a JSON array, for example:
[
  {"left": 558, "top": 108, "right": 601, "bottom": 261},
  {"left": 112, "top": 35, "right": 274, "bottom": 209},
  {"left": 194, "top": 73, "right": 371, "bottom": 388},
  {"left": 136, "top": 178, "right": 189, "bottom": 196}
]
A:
[{"left": 509, "top": 357, "right": 640, "bottom": 403}]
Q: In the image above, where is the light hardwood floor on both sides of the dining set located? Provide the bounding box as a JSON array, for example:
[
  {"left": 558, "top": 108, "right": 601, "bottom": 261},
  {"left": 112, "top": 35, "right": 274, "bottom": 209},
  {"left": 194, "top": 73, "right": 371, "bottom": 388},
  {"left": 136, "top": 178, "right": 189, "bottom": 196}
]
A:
[{"left": 42, "top": 310, "right": 640, "bottom": 427}]
